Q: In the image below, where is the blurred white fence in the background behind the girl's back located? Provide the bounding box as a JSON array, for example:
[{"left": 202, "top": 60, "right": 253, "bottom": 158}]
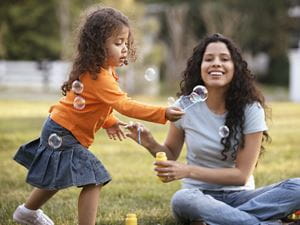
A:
[{"left": 0, "top": 61, "right": 71, "bottom": 91}]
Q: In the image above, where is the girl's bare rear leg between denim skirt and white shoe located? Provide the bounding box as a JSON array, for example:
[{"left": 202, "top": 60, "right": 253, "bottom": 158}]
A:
[{"left": 25, "top": 188, "right": 57, "bottom": 210}]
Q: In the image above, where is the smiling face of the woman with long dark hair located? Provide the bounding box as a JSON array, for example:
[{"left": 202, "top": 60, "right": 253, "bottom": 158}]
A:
[{"left": 201, "top": 42, "right": 234, "bottom": 88}]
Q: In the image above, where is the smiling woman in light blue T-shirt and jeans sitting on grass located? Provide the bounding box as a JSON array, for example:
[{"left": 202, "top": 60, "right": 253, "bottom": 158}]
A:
[{"left": 127, "top": 34, "right": 300, "bottom": 225}]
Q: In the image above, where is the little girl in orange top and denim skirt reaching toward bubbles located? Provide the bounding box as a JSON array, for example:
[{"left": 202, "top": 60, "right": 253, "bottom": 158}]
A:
[{"left": 13, "top": 5, "right": 183, "bottom": 225}]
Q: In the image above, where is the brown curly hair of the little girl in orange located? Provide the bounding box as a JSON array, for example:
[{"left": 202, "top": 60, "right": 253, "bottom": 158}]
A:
[{"left": 61, "top": 6, "right": 135, "bottom": 95}]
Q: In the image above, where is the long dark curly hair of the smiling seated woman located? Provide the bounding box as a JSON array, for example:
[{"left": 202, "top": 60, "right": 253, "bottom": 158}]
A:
[{"left": 177, "top": 34, "right": 270, "bottom": 160}]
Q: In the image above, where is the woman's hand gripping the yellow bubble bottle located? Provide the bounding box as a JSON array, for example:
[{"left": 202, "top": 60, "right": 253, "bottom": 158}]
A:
[{"left": 154, "top": 160, "right": 189, "bottom": 183}]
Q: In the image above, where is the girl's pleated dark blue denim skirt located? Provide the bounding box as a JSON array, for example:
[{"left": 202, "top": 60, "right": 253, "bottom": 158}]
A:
[{"left": 14, "top": 117, "right": 111, "bottom": 190}]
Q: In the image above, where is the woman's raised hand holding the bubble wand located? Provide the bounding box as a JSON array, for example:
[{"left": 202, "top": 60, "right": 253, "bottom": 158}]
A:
[{"left": 125, "top": 122, "right": 153, "bottom": 148}]
